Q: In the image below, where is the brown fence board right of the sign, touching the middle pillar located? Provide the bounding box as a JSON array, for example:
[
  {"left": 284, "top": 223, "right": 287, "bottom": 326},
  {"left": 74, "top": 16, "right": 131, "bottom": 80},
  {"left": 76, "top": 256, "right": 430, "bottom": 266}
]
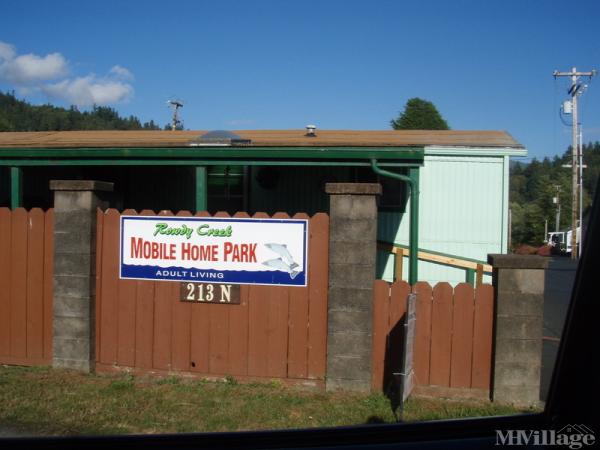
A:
[{"left": 308, "top": 213, "right": 329, "bottom": 379}]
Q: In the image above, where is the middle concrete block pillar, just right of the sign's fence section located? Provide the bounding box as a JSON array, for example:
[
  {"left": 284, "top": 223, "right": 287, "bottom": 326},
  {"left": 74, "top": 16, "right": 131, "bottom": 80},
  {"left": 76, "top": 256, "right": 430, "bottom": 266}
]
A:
[{"left": 325, "top": 183, "right": 381, "bottom": 392}]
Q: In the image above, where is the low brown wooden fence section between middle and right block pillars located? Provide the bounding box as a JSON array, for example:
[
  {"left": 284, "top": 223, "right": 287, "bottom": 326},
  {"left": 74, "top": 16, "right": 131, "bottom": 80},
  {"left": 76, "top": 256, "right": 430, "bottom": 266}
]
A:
[{"left": 372, "top": 280, "right": 494, "bottom": 390}]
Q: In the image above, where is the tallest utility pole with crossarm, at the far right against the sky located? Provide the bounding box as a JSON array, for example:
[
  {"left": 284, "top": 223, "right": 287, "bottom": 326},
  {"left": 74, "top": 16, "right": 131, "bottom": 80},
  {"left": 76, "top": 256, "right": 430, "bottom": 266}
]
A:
[{"left": 553, "top": 67, "right": 596, "bottom": 259}]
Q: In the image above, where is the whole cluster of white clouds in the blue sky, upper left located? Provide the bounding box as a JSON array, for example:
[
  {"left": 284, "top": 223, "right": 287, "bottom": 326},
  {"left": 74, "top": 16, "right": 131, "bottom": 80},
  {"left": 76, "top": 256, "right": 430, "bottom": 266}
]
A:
[{"left": 0, "top": 41, "right": 134, "bottom": 107}]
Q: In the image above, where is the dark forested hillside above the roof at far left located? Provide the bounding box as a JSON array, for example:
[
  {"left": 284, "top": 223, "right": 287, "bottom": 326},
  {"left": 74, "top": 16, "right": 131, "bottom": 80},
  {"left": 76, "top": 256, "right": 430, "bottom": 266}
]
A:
[{"left": 0, "top": 92, "right": 160, "bottom": 131}]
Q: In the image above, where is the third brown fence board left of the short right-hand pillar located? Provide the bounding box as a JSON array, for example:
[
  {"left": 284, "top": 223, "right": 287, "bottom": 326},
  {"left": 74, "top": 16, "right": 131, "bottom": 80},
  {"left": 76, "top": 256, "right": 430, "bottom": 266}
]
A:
[{"left": 429, "top": 283, "right": 452, "bottom": 386}]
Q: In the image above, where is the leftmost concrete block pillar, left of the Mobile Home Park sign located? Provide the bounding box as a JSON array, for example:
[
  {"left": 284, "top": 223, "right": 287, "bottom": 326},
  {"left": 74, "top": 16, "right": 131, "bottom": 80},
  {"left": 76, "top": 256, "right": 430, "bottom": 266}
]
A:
[{"left": 50, "top": 180, "right": 113, "bottom": 372}]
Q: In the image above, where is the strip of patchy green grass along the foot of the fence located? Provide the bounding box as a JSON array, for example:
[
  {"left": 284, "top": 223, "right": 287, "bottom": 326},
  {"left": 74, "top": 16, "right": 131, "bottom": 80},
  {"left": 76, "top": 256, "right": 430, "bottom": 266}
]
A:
[{"left": 0, "top": 366, "right": 522, "bottom": 435}]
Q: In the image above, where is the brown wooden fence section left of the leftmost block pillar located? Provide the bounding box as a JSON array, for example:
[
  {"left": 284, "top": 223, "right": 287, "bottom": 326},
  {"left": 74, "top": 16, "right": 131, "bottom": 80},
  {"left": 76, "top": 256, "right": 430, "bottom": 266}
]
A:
[{"left": 0, "top": 208, "right": 54, "bottom": 366}]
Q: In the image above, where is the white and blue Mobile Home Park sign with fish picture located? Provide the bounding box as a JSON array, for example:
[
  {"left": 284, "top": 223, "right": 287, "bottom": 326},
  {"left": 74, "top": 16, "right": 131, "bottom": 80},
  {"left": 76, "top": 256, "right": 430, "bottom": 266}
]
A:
[{"left": 119, "top": 216, "right": 308, "bottom": 286}]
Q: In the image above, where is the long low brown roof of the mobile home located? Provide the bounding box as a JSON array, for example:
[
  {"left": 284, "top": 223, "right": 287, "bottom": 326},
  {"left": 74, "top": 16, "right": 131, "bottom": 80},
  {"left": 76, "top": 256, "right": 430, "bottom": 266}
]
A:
[{"left": 0, "top": 129, "right": 523, "bottom": 149}]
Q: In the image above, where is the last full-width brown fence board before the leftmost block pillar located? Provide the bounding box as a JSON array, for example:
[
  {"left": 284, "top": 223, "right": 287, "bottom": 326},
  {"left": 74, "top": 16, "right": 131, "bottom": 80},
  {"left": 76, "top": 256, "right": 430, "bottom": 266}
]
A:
[{"left": 26, "top": 208, "right": 45, "bottom": 359}]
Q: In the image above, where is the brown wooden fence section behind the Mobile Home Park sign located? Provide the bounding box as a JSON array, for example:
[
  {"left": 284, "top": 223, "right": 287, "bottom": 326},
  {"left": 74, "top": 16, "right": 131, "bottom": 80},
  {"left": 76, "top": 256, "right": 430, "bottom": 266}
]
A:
[{"left": 96, "top": 209, "right": 329, "bottom": 384}]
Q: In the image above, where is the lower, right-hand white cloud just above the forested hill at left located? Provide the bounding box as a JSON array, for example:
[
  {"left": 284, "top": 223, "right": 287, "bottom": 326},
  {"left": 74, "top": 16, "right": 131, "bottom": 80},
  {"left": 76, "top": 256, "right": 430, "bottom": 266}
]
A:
[{"left": 41, "top": 75, "right": 133, "bottom": 107}]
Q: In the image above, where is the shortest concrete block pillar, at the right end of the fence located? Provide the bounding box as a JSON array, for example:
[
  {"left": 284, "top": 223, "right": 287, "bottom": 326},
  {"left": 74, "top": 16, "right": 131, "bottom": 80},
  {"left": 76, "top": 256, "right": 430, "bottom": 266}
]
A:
[{"left": 488, "top": 255, "right": 548, "bottom": 406}]
